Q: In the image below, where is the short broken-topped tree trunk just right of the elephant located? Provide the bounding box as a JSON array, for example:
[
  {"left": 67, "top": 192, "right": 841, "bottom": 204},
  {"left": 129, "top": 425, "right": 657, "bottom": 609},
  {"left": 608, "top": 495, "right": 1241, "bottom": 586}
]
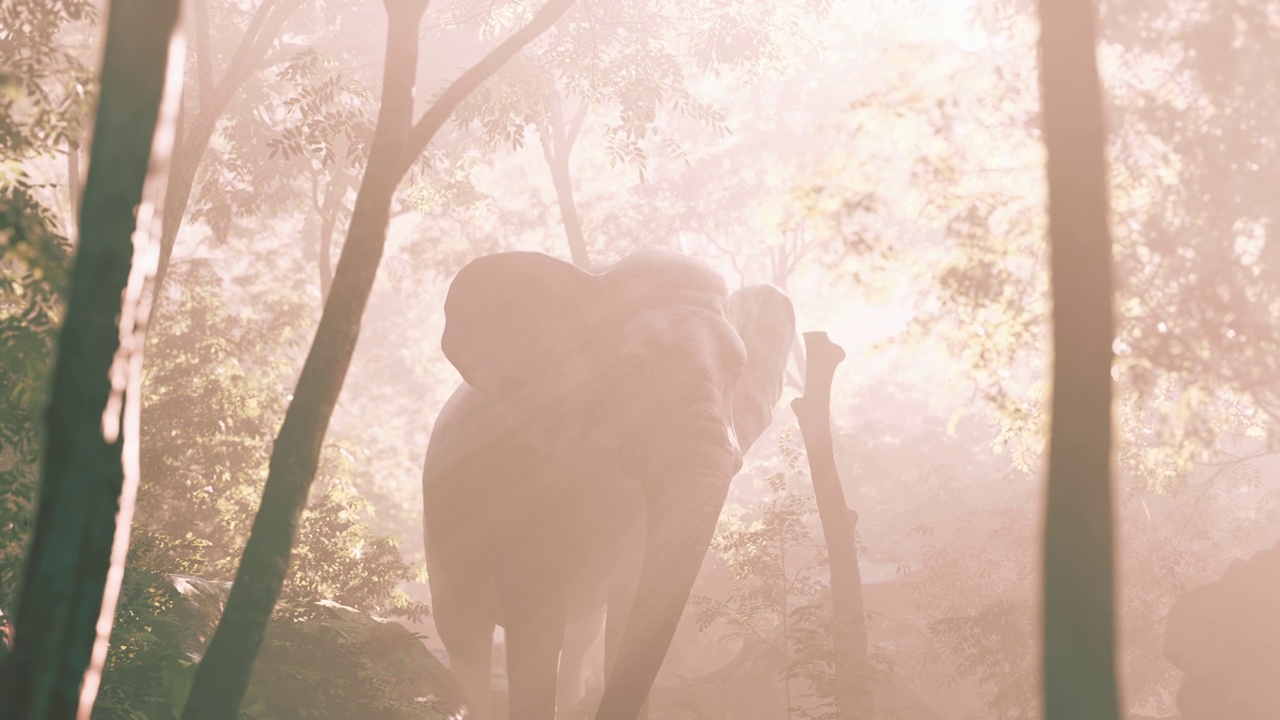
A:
[{"left": 791, "top": 332, "right": 873, "bottom": 720}]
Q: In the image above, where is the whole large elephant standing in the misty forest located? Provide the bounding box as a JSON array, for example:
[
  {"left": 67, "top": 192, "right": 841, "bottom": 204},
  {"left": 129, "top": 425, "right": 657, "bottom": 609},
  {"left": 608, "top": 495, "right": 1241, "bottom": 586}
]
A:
[{"left": 422, "top": 250, "right": 795, "bottom": 720}]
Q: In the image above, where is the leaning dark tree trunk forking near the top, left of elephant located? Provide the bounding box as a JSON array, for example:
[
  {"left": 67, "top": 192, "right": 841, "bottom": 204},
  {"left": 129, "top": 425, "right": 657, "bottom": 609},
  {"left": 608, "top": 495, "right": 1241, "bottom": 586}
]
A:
[{"left": 183, "top": 0, "right": 573, "bottom": 720}]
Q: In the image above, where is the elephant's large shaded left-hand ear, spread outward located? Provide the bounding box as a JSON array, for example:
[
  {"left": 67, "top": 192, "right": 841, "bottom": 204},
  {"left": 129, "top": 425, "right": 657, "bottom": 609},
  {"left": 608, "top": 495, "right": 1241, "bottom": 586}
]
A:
[{"left": 440, "top": 252, "right": 599, "bottom": 455}]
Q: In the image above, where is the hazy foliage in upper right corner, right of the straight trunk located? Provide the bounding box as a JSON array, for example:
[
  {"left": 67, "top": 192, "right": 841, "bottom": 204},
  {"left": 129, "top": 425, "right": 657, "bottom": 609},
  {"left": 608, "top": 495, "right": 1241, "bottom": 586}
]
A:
[{"left": 1103, "top": 0, "right": 1280, "bottom": 419}]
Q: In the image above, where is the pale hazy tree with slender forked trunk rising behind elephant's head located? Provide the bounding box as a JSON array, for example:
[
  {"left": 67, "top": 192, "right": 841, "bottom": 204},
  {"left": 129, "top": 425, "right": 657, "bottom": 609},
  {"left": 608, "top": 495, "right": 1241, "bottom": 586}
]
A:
[{"left": 445, "top": 0, "right": 826, "bottom": 268}]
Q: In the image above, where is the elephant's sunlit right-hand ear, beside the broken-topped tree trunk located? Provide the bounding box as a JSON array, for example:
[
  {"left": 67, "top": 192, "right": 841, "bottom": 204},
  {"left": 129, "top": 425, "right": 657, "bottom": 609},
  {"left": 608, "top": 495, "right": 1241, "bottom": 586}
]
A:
[{"left": 727, "top": 284, "right": 796, "bottom": 452}]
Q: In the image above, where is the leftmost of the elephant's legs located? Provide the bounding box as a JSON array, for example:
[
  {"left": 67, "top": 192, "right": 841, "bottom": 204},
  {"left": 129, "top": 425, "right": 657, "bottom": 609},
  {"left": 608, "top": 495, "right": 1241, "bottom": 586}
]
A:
[{"left": 431, "top": 597, "right": 494, "bottom": 720}]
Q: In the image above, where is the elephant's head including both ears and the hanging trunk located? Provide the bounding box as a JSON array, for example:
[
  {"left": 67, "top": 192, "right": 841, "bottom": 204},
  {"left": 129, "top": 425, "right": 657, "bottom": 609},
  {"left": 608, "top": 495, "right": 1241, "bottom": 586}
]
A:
[{"left": 442, "top": 251, "right": 795, "bottom": 717}]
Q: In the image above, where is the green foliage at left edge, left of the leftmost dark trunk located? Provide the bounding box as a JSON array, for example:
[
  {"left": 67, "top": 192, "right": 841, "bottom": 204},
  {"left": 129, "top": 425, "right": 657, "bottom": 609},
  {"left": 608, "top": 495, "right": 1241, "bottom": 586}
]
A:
[{"left": 0, "top": 0, "right": 85, "bottom": 609}]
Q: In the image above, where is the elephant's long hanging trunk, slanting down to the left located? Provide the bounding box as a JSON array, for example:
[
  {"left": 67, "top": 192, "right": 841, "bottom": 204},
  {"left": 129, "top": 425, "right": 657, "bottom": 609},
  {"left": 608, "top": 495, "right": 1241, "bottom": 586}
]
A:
[{"left": 595, "top": 424, "right": 741, "bottom": 720}]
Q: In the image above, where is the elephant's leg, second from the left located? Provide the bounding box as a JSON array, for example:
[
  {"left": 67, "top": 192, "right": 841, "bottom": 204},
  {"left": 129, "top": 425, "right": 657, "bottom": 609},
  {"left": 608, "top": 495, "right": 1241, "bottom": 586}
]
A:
[{"left": 503, "top": 597, "right": 564, "bottom": 720}]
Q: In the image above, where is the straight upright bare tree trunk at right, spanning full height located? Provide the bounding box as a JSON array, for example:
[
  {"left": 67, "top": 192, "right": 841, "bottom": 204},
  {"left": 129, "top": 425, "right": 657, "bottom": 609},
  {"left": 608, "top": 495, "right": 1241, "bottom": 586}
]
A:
[{"left": 1039, "top": 0, "right": 1120, "bottom": 720}]
